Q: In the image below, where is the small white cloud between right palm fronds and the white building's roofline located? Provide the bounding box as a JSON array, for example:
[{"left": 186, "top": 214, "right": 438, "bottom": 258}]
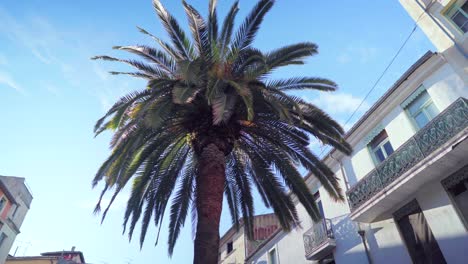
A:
[{"left": 309, "top": 92, "right": 369, "bottom": 115}]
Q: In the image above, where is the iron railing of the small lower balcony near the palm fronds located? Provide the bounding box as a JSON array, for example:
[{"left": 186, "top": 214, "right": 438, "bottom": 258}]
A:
[{"left": 303, "top": 219, "right": 335, "bottom": 256}]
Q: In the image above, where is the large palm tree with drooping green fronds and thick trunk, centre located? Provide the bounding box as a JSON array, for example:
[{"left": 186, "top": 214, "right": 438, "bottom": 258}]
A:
[{"left": 93, "top": 0, "right": 351, "bottom": 264}]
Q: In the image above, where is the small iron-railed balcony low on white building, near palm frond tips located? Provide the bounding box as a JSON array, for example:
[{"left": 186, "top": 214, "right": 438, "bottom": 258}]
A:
[{"left": 303, "top": 219, "right": 336, "bottom": 261}]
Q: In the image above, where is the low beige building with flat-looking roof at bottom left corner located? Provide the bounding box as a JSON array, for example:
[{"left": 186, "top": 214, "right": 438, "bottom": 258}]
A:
[{"left": 5, "top": 249, "right": 86, "bottom": 264}]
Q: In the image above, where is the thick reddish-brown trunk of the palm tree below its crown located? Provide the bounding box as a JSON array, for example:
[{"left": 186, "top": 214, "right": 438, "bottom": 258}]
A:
[{"left": 193, "top": 143, "right": 226, "bottom": 264}]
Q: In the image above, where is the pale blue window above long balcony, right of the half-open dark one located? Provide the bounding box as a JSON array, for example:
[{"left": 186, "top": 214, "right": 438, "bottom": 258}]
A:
[{"left": 406, "top": 90, "right": 439, "bottom": 129}]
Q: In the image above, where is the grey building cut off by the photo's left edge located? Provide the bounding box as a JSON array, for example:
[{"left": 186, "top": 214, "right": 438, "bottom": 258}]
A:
[{"left": 0, "top": 176, "right": 33, "bottom": 263}]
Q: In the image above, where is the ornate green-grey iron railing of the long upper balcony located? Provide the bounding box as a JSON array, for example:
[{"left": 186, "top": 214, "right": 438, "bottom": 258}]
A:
[{"left": 347, "top": 98, "right": 468, "bottom": 210}]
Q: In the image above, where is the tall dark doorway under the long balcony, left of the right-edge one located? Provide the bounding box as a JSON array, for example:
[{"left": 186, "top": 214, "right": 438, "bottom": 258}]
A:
[{"left": 394, "top": 200, "right": 447, "bottom": 264}]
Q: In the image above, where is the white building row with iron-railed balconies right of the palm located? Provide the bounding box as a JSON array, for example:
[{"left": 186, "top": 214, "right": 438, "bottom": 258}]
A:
[{"left": 247, "top": 0, "right": 468, "bottom": 264}]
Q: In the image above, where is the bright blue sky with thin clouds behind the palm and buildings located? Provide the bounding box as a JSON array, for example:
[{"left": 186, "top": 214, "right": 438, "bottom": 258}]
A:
[{"left": 0, "top": 0, "right": 434, "bottom": 264}]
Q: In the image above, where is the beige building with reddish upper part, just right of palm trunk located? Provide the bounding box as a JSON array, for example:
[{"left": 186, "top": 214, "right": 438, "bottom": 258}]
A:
[{"left": 219, "top": 214, "right": 279, "bottom": 264}]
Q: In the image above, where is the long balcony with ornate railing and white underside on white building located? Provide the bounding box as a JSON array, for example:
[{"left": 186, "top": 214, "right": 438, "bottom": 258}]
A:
[{"left": 347, "top": 98, "right": 468, "bottom": 223}]
